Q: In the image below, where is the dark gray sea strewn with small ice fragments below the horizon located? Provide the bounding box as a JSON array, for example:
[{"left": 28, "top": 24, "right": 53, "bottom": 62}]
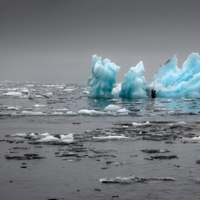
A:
[{"left": 0, "top": 83, "right": 200, "bottom": 200}]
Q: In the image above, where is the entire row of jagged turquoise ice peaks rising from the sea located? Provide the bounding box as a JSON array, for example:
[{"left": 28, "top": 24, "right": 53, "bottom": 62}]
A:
[{"left": 88, "top": 53, "right": 200, "bottom": 99}]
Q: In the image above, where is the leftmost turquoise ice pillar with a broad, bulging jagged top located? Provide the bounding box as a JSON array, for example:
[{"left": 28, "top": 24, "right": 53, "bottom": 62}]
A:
[{"left": 88, "top": 55, "right": 120, "bottom": 99}]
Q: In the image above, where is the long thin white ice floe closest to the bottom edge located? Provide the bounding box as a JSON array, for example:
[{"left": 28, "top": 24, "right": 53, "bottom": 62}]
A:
[{"left": 99, "top": 176, "right": 175, "bottom": 183}]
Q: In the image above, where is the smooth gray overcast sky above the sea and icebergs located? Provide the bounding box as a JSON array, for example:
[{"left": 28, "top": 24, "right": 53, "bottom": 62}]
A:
[{"left": 0, "top": 0, "right": 200, "bottom": 82}]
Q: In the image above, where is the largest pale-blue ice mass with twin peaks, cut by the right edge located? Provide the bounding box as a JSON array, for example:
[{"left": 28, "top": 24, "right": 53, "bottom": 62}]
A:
[{"left": 148, "top": 53, "right": 200, "bottom": 98}]
